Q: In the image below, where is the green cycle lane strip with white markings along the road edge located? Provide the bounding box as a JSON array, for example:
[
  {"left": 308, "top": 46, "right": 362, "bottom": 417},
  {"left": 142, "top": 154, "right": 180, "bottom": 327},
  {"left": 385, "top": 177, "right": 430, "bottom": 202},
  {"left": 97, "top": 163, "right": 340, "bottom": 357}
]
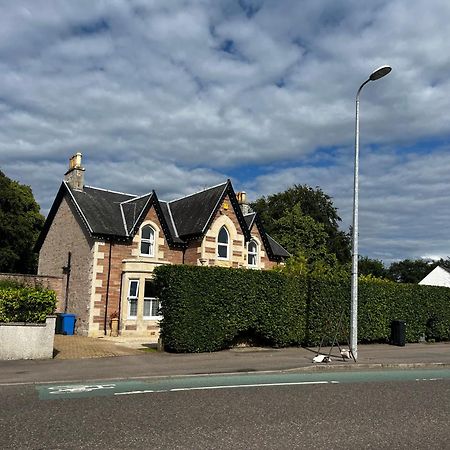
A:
[{"left": 36, "top": 369, "right": 450, "bottom": 400}]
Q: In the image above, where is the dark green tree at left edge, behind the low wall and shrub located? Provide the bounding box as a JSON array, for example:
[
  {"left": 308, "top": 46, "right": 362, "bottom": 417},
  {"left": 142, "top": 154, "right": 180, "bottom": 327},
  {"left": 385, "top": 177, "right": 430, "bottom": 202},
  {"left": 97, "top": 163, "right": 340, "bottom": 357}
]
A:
[{"left": 0, "top": 171, "right": 44, "bottom": 273}]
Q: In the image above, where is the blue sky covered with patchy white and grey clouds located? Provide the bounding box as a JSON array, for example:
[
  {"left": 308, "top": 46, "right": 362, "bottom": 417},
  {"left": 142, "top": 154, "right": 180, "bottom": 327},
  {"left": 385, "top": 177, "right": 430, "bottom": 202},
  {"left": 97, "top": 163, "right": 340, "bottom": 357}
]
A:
[{"left": 0, "top": 0, "right": 450, "bottom": 264}]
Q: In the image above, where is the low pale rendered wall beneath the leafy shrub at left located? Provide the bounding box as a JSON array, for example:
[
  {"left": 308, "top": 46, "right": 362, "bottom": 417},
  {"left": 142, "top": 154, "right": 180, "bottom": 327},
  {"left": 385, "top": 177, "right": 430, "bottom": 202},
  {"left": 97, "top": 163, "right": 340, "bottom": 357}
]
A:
[{"left": 0, "top": 316, "right": 56, "bottom": 360}]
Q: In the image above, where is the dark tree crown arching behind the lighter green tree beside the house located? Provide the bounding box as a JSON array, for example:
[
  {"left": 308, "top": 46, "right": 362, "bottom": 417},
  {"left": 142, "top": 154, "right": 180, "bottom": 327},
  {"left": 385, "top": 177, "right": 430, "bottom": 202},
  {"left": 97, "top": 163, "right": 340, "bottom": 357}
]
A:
[{"left": 251, "top": 185, "right": 351, "bottom": 263}]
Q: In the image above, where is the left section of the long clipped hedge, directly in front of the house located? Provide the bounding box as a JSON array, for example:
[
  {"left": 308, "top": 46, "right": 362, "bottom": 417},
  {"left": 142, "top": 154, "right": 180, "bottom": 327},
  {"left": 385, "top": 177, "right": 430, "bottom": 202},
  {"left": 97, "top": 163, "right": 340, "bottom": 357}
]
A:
[{"left": 155, "top": 266, "right": 306, "bottom": 352}]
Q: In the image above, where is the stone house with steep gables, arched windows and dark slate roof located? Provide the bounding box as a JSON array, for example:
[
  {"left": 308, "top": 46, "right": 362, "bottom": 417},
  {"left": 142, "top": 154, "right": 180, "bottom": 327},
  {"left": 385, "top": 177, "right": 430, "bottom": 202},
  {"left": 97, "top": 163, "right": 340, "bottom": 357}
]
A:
[{"left": 36, "top": 153, "right": 289, "bottom": 338}]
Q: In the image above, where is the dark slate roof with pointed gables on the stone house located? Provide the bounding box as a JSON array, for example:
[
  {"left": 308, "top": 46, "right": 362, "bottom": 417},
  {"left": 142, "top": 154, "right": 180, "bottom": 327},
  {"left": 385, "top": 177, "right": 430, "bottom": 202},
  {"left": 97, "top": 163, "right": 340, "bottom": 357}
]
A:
[{"left": 36, "top": 180, "right": 289, "bottom": 259}]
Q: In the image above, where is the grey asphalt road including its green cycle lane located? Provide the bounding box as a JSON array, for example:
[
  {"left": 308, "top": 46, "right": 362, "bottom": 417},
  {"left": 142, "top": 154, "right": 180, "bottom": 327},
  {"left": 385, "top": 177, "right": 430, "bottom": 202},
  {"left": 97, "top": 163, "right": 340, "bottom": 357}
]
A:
[{"left": 0, "top": 369, "right": 450, "bottom": 449}]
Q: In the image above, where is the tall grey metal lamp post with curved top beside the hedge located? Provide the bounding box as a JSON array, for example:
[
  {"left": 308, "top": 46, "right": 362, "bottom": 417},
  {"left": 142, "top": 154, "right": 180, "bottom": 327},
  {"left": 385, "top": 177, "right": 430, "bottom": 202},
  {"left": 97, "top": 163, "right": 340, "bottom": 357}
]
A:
[{"left": 350, "top": 66, "right": 392, "bottom": 361}]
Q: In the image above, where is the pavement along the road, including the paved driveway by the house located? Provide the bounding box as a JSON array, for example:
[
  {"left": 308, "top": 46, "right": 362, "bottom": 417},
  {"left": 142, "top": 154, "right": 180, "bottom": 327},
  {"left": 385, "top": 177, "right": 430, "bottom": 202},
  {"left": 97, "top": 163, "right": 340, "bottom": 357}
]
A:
[{"left": 0, "top": 336, "right": 450, "bottom": 385}]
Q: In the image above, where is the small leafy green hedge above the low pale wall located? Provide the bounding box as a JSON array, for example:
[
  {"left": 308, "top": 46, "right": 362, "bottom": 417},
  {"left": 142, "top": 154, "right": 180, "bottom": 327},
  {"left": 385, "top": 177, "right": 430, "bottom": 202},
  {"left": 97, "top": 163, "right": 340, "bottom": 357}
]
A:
[{"left": 0, "top": 286, "right": 56, "bottom": 323}]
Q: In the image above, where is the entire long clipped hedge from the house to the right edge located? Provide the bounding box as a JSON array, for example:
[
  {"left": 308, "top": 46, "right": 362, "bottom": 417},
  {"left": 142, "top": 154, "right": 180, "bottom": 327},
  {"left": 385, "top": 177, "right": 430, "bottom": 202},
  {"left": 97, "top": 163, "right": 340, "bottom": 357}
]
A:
[{"left": 155, "top": 265, "right": 450, "bottom": 352}]
